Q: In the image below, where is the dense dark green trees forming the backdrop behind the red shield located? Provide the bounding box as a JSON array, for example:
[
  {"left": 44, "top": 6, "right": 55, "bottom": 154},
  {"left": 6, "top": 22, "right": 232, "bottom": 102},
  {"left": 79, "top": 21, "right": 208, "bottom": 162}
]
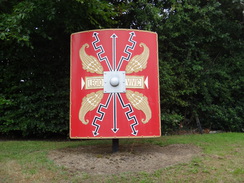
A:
[{"left": 0, "top": 0, "right": 244, "bottom": 136}]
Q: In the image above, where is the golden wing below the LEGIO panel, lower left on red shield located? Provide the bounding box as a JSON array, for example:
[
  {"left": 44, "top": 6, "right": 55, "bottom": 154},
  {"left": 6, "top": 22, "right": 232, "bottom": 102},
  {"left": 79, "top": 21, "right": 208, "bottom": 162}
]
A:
[{"left": 79, "top": 90, "right": 103, "bottom": 125}]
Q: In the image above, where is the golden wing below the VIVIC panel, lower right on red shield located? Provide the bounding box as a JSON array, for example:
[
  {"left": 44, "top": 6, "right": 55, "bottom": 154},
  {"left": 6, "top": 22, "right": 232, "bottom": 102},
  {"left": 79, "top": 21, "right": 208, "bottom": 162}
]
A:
[{"left": 126, "top": 90, "right": 152, "bottom": 124}]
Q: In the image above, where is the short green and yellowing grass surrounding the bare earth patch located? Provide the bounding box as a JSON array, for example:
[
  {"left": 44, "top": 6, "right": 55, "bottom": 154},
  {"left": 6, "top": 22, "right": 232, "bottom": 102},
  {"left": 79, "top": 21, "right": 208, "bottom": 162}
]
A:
[{"left": 0, "top": 133, "right": 244, "bottom": 183}]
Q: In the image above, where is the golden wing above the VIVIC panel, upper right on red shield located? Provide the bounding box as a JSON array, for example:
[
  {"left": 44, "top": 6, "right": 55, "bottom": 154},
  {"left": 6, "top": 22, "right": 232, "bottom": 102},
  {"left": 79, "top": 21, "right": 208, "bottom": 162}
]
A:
[{"left": 125, "top": 43, "right": 150, "bottom": 74}]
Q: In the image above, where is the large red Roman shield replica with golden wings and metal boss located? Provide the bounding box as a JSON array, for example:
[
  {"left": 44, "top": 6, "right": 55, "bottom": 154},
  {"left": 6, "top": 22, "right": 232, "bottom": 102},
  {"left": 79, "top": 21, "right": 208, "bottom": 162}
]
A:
[{"left": 70, "top": 29, "right": 161, "bottom": 138}]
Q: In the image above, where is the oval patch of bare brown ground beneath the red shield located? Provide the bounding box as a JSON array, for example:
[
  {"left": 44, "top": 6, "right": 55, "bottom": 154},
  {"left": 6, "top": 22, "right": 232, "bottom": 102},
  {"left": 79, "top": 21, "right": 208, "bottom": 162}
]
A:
[{"left": 49, "top": 144, "right": 201, "bottom": 175}]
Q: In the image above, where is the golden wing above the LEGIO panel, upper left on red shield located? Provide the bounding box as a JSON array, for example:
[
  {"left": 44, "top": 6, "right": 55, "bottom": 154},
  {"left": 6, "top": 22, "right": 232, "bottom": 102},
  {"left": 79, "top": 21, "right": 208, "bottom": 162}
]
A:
[{"left": 79, "top": 43, "right": 103, "bottom": 74}]
